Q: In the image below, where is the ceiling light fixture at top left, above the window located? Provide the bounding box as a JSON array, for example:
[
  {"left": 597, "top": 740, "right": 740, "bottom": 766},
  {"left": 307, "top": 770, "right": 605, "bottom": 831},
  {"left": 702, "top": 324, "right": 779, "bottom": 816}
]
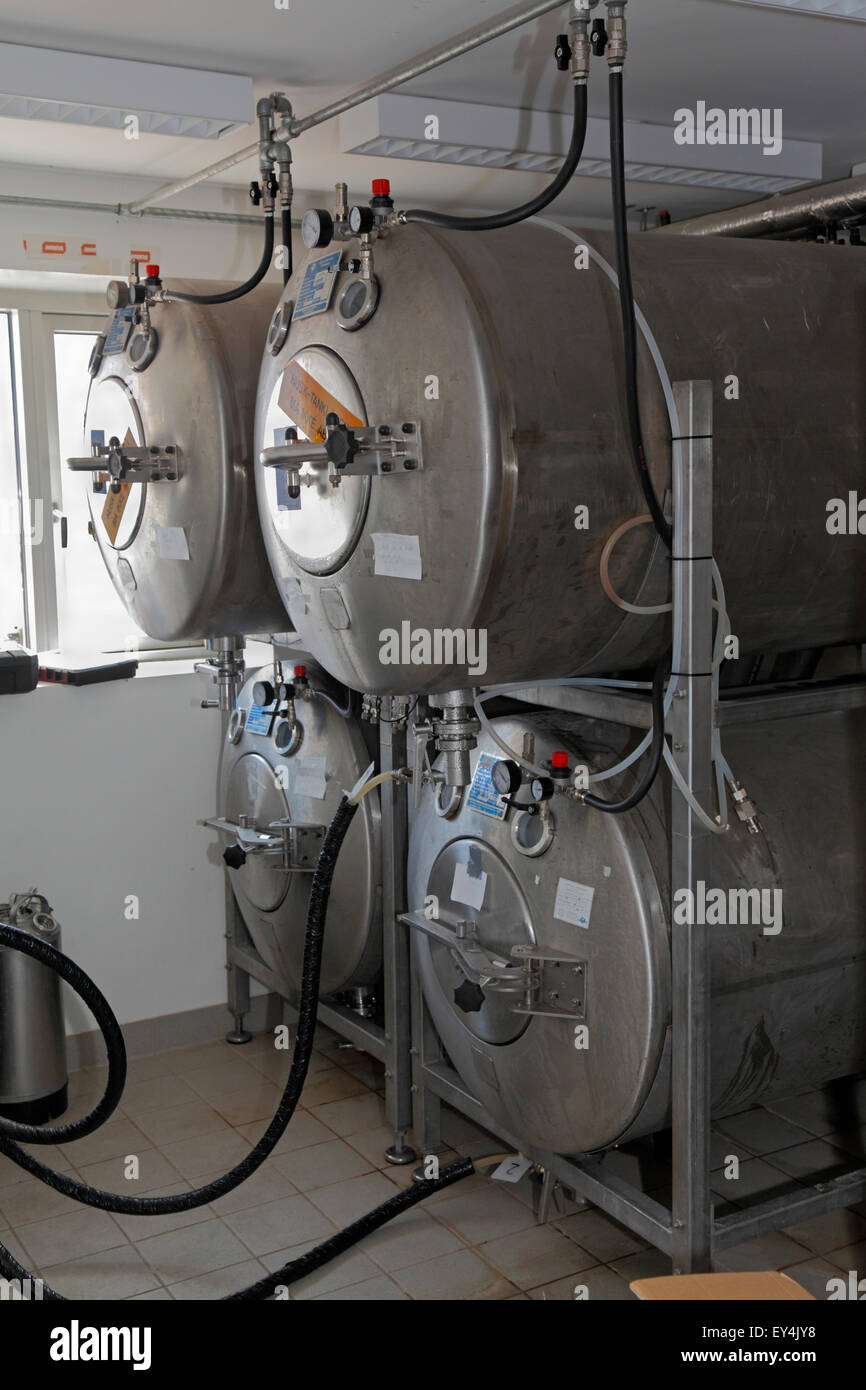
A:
[{"left": 0, "top": 43, "right": 254, "bottom": 140}]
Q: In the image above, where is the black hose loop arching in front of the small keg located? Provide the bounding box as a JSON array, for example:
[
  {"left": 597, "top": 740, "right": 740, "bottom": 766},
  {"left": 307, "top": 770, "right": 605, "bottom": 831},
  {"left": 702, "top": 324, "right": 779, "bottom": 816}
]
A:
[{"left": 0, "top": 923, "right": 126, "bottom": 1139}]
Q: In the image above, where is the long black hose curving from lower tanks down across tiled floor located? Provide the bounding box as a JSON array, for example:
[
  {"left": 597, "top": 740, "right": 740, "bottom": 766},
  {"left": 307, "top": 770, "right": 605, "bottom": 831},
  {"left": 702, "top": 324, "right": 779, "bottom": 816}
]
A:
[{"left": 0, "top": 796, "right": 357, "bottom": 1216}]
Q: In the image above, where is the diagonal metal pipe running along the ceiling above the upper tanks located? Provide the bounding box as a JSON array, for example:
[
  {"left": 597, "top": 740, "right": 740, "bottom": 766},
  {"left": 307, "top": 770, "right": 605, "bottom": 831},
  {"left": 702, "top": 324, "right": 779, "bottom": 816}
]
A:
[{"left": 125, "top": 0, "right": 563, "bottom": 213}]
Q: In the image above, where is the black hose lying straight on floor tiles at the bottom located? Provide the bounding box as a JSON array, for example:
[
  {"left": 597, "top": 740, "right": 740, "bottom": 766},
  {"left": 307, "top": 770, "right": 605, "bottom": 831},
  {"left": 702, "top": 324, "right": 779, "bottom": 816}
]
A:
[{"left": 0, "top": 1158, "right": 475, "bottom": 1302}]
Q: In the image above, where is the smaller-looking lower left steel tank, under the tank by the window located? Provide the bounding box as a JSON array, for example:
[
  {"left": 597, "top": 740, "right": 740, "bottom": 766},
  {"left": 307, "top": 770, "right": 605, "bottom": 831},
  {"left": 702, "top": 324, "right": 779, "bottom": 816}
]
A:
[{"left": 220, "top": 666, "right": 382, "bottom": 998}]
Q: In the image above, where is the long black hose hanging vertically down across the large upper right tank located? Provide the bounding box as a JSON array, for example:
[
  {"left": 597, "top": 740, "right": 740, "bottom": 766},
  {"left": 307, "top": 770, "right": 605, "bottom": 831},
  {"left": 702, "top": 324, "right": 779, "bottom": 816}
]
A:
[{"left": 610, "top": 71, "right": 673, "bottom": 550}]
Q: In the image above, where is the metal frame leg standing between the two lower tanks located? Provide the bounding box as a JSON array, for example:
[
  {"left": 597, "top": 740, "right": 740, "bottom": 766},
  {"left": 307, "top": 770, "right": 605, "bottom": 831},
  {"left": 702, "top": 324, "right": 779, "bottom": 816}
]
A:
[{"left": 379, "top": 699, "right": 417, "bottom": 1165}]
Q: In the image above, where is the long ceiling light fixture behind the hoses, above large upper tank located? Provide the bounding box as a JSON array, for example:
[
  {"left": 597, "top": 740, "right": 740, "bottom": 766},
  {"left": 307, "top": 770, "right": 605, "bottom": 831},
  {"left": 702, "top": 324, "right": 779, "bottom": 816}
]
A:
[{"left": 341, "top": 93, "right": 823, "bottom": 193}]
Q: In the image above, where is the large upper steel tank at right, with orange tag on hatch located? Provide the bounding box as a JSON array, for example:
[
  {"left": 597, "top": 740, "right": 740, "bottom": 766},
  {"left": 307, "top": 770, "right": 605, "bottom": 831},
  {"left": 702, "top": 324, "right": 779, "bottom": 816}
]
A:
[{"left": 256, "top": 222, "right": 866, "bottom": 694}]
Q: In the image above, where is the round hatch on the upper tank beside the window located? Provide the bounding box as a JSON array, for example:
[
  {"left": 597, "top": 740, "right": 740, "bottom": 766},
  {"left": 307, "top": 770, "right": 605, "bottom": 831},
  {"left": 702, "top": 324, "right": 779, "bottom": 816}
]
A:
[{"left": 82, "top": 377, "right": 147, "bottom": 550}]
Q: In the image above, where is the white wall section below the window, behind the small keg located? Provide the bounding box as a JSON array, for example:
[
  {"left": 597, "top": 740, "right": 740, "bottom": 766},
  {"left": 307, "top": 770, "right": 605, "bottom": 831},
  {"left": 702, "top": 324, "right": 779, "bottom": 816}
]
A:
[{"left": 0, "top": 674, "right": 232, "bottom": 1033}]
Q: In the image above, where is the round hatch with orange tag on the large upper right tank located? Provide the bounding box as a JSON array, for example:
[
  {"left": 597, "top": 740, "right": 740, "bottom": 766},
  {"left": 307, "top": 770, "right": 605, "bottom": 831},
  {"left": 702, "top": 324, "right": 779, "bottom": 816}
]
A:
[{"left": 263, "top": 348, "right": 370, "bottom": 574}]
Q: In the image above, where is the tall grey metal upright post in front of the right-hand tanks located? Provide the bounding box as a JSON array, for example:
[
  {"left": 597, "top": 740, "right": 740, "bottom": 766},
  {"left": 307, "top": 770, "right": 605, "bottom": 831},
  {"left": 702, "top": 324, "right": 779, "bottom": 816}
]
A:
[{"left": 667, "top": 381, "right": 714, "bottom": 1273}]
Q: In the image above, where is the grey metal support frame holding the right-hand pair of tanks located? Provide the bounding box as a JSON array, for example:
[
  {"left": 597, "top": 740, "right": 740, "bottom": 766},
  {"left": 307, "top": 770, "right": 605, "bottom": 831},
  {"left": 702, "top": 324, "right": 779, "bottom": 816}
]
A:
[{"left": 400, "top": 381, "right": 866, "bottom": 1273}]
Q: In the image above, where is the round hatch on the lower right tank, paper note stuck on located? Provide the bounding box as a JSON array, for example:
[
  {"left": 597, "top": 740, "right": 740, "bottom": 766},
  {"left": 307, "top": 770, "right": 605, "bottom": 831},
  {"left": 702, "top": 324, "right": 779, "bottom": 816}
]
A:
[{"left": 427, "top": 840, "right": 535, "bottom": 1045}]
